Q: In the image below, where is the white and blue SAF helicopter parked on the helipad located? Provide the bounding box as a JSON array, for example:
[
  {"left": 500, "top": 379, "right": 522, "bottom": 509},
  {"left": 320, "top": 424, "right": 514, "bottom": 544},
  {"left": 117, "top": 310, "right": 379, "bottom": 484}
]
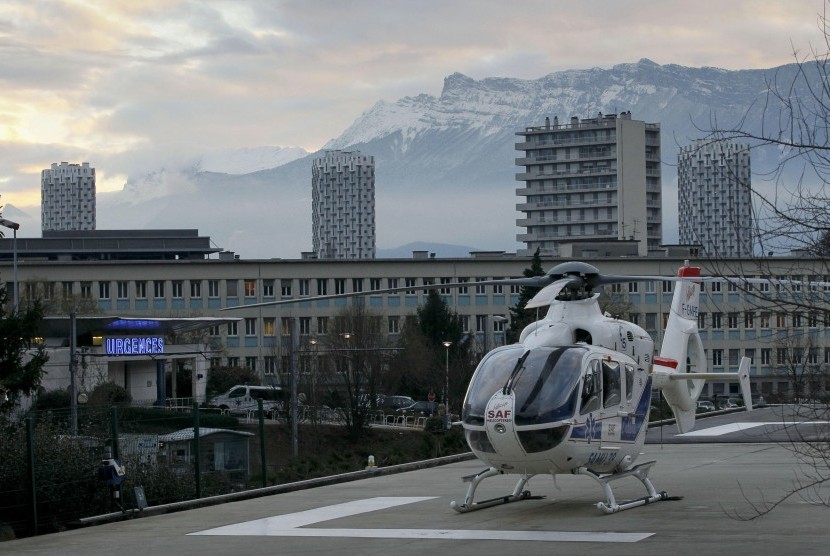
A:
[{"left": 228, "top": 261, "right": 772, "bottom": 513}]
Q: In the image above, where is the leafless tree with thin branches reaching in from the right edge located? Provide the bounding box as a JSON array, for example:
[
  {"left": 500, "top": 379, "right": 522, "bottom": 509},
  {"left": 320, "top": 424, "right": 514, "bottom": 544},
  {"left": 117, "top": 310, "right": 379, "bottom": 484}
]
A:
[{"left": 706, "top": 3, "right": 830, "bottom": 519}]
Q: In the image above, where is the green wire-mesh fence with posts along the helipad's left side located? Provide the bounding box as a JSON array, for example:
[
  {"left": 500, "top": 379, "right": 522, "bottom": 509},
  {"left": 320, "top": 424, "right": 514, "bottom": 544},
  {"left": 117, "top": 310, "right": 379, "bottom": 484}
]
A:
[{"left": 0, "top": 403, "right": 448, "bottom": 537}]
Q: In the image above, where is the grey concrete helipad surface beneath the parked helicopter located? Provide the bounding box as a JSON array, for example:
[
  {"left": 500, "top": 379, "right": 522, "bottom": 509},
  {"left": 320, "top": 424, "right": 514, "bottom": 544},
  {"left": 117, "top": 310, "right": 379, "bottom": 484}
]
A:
[{"left": 6, "top": 406, "right": 830, "bottom": 556}]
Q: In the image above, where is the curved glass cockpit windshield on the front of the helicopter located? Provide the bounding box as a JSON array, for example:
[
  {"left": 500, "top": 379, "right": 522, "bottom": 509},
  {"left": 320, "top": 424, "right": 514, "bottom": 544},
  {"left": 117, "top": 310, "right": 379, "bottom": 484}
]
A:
[{"left": 462, "top": 346, "right": 588, "bottom": 426}]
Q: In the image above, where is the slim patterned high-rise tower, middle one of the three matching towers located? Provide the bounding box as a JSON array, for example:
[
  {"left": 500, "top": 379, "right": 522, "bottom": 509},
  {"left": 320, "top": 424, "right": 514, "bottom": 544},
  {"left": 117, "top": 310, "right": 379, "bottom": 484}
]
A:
[{"left": 311, "top": 151, "right": 375, "bottom": 259}]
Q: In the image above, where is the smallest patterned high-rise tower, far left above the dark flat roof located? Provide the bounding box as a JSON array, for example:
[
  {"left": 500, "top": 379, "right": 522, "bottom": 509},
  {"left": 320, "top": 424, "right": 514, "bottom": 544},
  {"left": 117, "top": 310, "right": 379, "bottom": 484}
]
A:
[{"left": 40, "top": 162, "right": 95, "bottom": 230}]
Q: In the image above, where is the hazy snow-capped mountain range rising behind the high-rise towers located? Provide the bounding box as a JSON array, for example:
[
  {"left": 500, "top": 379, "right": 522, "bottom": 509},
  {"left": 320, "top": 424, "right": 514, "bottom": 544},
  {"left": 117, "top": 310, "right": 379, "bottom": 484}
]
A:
[{"left": 98, "top": 60, "right": 808, "bottom": 258}]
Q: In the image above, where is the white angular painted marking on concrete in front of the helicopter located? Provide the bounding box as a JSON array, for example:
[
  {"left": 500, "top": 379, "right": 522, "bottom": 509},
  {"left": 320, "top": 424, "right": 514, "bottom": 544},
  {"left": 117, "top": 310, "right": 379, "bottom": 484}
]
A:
[{"left": 188, "top": 496, "right": 654, "bottom": 542}]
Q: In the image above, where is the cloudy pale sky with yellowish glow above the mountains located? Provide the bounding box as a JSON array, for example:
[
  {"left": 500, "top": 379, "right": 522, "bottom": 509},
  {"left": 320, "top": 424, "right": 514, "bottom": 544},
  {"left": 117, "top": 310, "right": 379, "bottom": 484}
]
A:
[{"left": 0, "top": 0, "right": 827, "bottom": 237}]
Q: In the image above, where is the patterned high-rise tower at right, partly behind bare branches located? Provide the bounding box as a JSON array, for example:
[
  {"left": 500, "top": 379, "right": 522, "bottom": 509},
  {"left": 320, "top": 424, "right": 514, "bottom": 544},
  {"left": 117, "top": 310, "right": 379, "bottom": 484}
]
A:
[{"left": 677, "top": 140, "right": 754, "bottom": 257}]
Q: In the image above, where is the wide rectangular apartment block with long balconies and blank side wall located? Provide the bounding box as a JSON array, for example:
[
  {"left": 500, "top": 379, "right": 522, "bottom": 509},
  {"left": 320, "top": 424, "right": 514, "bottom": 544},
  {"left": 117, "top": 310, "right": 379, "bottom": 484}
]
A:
[{"left": 516, "top": 112, "right": 663, "bottom": 256}]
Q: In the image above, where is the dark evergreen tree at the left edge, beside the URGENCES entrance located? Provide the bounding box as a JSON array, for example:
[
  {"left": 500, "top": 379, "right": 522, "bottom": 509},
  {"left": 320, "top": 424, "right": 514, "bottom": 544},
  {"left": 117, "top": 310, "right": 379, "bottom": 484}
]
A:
[{"left": 0, "top": 287, "right": 49, "bottom": 413}]
